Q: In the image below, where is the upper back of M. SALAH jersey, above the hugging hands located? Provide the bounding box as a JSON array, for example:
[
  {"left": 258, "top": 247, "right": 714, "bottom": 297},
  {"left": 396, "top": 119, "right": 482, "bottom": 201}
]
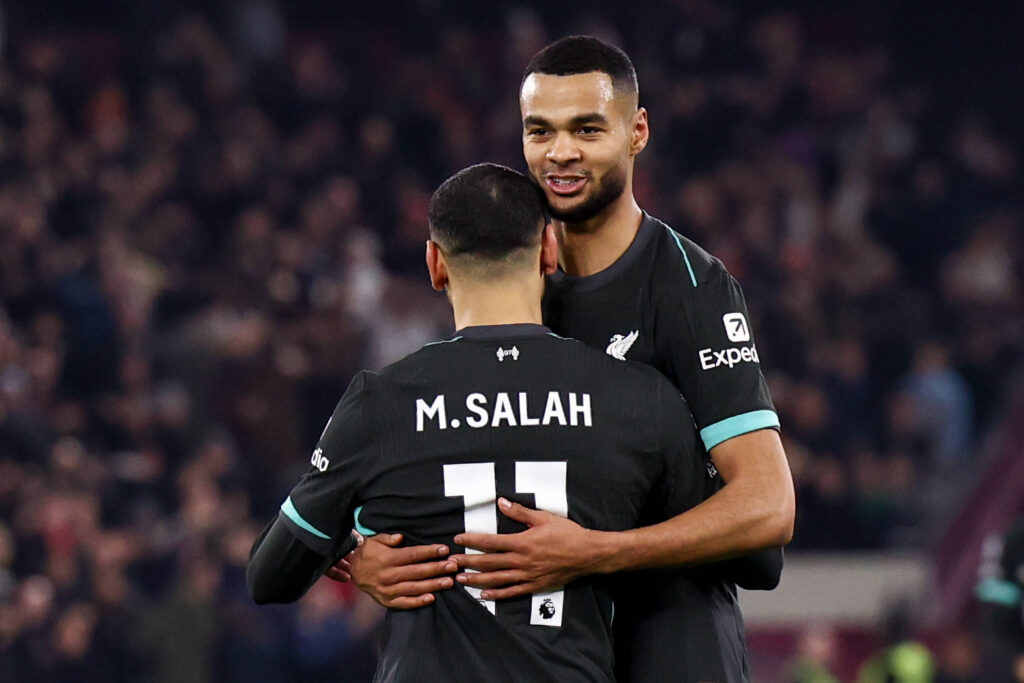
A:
[{"left": 360, "top": 326, "right": 692, "bottom": 543}]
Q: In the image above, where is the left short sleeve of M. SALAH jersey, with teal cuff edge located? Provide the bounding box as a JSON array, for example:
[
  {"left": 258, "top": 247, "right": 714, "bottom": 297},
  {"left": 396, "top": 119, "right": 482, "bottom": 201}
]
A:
[{"left": 279, "top": 372, "right": 375, "bottom": 555}]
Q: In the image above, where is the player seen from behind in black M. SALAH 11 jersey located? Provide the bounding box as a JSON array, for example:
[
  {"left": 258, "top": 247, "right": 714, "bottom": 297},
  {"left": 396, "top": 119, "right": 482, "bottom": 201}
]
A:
[{"left": 247, "top": 164, "right": 707, "bottom": 683}]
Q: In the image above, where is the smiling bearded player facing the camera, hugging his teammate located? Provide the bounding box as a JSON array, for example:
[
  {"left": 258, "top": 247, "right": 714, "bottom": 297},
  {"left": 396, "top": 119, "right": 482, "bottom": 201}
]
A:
[{"left": 336, "top": 36, "right": 795, "bottom": 681}]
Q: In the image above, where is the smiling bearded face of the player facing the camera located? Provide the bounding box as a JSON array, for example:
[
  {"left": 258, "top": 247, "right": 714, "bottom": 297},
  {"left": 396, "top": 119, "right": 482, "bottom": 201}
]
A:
[{"left": 519, "top": 72, "right": 647, "bottom": 224}]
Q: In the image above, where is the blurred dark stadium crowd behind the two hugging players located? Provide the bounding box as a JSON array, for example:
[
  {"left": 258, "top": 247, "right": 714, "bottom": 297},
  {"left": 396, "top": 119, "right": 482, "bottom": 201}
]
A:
[{"left": 0, "top": 0, "right": 1024, "bottom": 682}]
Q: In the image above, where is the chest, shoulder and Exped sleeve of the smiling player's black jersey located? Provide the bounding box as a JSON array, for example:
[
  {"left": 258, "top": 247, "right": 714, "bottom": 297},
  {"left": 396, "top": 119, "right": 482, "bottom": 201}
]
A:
[{"left": 544, "top": 214, "right": 778, "bottom": 451}]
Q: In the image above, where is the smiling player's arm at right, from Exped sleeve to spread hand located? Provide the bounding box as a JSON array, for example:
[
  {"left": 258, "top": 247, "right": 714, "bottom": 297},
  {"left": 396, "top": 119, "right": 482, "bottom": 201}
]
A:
[{"left": 453, "top": 263, "right": 796, "bottom": 598}]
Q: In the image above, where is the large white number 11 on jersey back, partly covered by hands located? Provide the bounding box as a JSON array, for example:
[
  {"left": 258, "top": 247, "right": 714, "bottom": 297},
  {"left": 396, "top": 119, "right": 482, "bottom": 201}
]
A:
[{"left": 444, "top": 461, "right": 568, "bottom": 628}]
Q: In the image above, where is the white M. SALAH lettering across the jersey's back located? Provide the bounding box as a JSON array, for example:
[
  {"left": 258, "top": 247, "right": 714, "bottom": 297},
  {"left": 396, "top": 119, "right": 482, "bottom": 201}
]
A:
[{"left": 416, "top": 391, "right": 594, "bottom": 432}]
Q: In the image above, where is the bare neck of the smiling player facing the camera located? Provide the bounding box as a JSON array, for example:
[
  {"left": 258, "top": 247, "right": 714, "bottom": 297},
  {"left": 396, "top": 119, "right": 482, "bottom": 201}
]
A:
[{"left": 554, "top": 191, "right": 643, "bottom": 278}]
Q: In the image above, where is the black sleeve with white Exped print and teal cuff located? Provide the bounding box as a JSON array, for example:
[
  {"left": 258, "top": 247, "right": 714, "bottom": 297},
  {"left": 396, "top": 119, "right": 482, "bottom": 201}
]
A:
[{"left": 656, "top": 259, "right": 779, "bottom": 451}]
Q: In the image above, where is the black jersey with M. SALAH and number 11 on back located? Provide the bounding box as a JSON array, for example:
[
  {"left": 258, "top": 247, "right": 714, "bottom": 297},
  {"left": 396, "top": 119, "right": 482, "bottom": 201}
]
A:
[{"left": 279, "top": 325, "right": 707, "bottom": 683}]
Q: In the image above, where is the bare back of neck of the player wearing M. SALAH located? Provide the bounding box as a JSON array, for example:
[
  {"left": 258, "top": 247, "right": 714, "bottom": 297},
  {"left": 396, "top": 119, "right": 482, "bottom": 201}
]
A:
[{"left": 449, "top": 279, "right": 544, "bottom": 330}]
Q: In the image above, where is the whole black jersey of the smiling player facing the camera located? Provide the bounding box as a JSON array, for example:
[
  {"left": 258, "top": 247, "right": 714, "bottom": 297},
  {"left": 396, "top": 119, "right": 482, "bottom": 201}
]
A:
[{"left": 544, "top": 214, "right": 781, "bottom": 683}]
